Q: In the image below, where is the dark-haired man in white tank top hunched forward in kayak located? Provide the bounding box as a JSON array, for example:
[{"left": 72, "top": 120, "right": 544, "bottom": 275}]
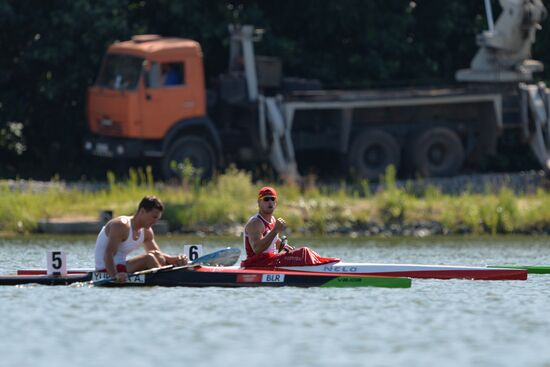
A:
[{"left": 95, "top": 196, "right": 188, "bottom": 283}]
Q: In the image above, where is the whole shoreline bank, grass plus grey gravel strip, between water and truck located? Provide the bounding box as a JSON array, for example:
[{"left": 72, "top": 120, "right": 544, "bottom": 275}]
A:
[{"left": 0, "top": 169, "right": 550, "bottom": 238}]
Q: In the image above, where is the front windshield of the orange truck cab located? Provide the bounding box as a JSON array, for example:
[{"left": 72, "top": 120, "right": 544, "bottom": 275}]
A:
[{"left": 96, "top": 54, "right": 143, "bottom": 90}]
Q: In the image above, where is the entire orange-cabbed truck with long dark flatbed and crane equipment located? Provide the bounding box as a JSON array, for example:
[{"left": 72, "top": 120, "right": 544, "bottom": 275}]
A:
[{"left": 84, "top": 0, "right": 550, "bottom": 180}]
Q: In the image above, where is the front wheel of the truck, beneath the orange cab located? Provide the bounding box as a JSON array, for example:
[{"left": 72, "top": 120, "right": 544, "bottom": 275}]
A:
[{"left": 162, "top": 136, "right": 216, "bottom": 179}]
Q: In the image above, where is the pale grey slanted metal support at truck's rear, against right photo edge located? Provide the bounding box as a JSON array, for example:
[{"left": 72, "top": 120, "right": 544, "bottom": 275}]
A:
[{"left": 519, "top": 82, "right": 550, "bottom": 173}]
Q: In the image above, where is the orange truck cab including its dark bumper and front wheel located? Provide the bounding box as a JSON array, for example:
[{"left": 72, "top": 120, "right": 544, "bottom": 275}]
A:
[{"left": 84, "top": 35, "right": 222, "bottom": 176}]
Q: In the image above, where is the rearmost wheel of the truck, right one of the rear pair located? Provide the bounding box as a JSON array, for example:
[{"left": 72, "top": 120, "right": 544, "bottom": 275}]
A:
[{"left": 407, "top": 127, "right": 464, "bottom": 177}]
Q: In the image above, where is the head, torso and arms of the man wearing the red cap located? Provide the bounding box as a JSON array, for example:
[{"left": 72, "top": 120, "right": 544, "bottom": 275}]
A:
[{"left": 244, "top": 186, "right": 292, "bottom": 258}]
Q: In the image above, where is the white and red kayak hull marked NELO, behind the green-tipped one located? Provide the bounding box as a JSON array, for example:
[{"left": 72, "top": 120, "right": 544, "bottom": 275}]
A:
[{"left": 272, "top": 262, "right": 527, "bottom": 280}]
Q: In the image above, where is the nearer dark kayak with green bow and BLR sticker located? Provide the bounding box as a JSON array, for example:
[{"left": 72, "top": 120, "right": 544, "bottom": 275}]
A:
[{"left": 0, "top": 265, "right": 411, "bottom": 288}]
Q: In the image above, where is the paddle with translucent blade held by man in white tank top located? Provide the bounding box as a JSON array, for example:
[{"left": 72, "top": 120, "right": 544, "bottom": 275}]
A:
[{"left": 91, "top": 247, "right": 241, "bottom": 285}]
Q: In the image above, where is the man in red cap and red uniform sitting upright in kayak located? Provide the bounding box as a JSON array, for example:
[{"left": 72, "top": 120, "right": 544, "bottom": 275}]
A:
[{"left": 241, "top": 186, "right": 339, "bottom": 268}]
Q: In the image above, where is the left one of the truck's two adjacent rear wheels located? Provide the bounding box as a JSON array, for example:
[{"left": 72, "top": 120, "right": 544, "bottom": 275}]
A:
[{"left": 348, "top": 129, "right": 401, "bottom": 180}]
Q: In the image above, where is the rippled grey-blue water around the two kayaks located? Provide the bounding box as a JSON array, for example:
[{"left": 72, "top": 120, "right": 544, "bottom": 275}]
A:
[{"left": 0, "top": 237, "right": 550, "bottom": 367}]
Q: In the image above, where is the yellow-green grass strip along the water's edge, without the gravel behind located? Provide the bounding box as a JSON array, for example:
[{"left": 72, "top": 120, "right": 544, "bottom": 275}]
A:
[{"left": 0, "top": 167, "right": 550, "bottom": 235}]
